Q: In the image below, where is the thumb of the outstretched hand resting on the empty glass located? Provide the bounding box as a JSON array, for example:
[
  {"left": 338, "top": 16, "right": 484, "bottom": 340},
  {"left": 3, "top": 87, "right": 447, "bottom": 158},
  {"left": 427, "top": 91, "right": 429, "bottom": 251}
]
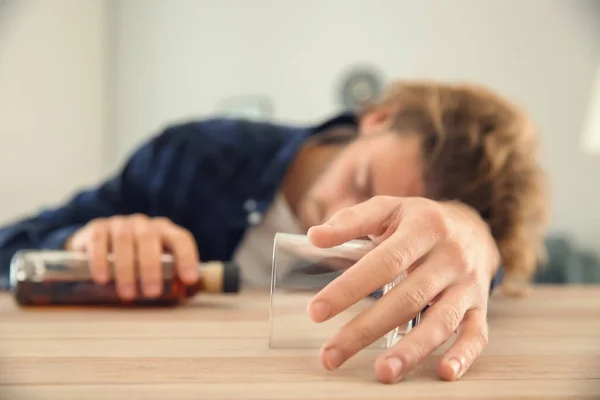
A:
[{"left": 307, "top": 196, "right": 402, "bottom": 247}]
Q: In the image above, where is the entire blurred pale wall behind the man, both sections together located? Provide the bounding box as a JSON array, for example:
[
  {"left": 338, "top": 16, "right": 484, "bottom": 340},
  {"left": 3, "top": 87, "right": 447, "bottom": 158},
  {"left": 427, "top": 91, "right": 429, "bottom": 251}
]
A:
[{"left": 0, "top": 0, "right": 600, "bottom": 253}]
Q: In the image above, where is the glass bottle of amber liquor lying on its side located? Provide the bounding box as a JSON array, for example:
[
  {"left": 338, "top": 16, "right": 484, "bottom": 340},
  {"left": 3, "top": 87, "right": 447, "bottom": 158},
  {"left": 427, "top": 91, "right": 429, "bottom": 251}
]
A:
[{"left": 10, "top": 250, "right": 240, "bottom": 306}]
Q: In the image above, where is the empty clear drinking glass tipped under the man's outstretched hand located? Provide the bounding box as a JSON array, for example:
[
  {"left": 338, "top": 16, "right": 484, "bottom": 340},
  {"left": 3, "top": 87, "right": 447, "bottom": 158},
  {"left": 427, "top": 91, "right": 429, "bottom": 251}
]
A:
[{"left": 269, "top": 233, "right": 419, "bottom": 348}]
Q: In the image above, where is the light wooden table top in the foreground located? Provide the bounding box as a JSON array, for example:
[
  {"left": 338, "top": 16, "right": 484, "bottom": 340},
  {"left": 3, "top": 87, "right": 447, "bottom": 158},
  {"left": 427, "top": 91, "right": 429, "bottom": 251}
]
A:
[{"left": 0, "top": 287, "right": 600, "bottom": 400}]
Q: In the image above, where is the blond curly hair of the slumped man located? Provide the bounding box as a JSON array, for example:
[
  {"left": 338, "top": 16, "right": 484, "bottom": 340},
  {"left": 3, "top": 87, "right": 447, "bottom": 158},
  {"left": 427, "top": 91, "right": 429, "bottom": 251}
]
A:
[{"left": 366, "top": 81, "right": 548, "bottom": 294}]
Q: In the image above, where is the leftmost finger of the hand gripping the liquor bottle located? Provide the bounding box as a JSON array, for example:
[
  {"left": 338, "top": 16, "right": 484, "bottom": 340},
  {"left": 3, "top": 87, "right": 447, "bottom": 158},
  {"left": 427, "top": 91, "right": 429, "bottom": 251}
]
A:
[{"left": 85, "top": 220, "right": 111, "bottom": 284}]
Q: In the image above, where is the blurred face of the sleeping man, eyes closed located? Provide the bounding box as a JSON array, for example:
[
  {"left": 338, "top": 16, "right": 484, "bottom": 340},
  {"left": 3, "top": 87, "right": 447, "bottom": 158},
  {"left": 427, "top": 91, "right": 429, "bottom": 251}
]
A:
[{"left": 297, "top": 114, "right": 423, "bottom": 229}]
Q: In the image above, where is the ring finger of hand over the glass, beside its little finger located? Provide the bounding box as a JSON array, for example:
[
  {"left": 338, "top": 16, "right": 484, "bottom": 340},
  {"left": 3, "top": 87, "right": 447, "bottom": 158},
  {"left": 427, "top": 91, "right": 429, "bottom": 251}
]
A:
[{"left": 375, "top": 286, "right": 473, "bottom": 383}]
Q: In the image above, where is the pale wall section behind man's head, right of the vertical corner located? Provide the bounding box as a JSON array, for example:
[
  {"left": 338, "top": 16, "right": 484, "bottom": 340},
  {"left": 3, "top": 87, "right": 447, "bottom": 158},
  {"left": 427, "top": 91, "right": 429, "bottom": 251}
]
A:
[{"left": 115, "top": 0, "right": 600, "bottom": 248}]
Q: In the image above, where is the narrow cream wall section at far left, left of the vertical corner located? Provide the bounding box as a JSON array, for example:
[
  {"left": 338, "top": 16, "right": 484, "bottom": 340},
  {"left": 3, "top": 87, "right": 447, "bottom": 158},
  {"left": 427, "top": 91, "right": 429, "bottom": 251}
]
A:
[{"left": 0, "top": 0, "right": 109, "bottom": 222}]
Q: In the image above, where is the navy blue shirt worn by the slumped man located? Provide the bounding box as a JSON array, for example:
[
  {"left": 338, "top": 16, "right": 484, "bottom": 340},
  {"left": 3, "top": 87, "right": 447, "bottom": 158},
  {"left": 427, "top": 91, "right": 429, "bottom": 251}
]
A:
[{"left": 0, "top": 115, "right": 502, "bottom": 289}]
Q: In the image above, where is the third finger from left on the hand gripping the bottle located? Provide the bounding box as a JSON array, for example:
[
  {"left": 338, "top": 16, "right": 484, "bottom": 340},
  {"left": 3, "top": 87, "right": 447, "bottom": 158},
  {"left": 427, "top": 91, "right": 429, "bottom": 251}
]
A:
[{"left": 132, "top": 217, "right": 163, "bottom": 297}]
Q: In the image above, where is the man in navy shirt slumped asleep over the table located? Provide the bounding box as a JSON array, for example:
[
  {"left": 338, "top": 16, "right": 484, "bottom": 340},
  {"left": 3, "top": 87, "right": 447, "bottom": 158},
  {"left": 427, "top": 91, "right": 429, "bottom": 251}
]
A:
[{"left": 0, "top": 82, "right": 546, "bottom": 382}]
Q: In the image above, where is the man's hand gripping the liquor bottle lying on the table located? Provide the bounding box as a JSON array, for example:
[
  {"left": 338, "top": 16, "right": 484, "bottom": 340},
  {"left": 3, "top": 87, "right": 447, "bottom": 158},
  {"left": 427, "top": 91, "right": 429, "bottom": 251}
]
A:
[{"left": 65, "top": 214, "right": 199, "bottom": 299}]
